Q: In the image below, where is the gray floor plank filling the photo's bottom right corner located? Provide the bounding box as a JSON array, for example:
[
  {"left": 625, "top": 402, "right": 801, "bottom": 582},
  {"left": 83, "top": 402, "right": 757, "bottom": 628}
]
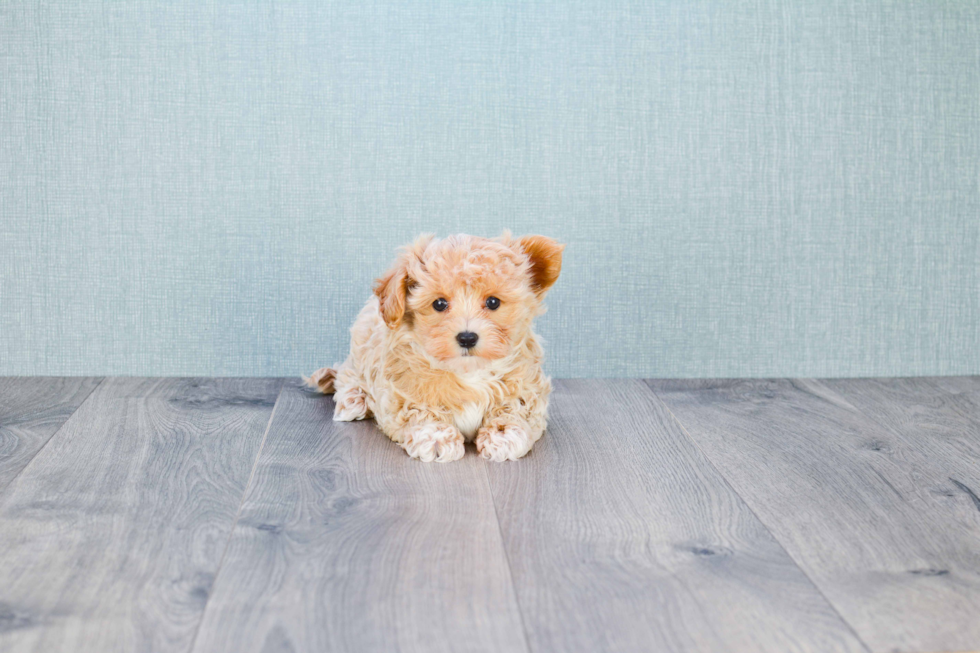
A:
[{"left": 649, "top": 380, "right": 980, "bottom": 651}]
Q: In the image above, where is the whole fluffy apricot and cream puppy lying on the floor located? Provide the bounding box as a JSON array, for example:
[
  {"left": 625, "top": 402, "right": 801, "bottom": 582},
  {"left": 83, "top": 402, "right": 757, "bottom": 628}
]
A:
[{"left": 307, "top": 232, "right": 565, "bottom": 462}]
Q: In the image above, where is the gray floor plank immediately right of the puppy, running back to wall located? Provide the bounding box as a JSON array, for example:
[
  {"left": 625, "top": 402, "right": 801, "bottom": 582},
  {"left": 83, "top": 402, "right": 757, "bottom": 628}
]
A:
[{"left": 487, "top": 380, "right": 864, "bottom": 653}]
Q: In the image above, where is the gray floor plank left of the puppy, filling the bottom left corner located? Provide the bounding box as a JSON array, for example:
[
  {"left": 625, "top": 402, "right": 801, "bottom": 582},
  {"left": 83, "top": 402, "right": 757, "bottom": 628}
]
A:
[{"left": 0, "top": 379, "right": 282, "bottom": 653}]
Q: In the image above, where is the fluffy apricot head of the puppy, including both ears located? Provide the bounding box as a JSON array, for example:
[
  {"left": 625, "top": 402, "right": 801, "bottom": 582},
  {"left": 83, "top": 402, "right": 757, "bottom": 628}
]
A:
[{"left": 374, "top": 232, "right": 565, "bottom": 372}]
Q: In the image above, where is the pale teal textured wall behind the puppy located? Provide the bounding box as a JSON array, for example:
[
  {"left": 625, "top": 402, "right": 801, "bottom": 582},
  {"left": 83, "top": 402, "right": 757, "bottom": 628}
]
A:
[{"left": 0, "top": 0, "right": 980, "bottom": 376}]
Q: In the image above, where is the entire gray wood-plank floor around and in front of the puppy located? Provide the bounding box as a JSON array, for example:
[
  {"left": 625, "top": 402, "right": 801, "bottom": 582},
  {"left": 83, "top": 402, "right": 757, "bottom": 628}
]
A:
[{"left": 0, "top": 377, "right": 980, "bottom": 653}]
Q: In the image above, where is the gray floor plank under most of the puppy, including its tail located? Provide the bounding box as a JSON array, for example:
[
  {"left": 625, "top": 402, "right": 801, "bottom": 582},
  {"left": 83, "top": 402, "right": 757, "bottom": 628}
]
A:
[{"left": 194, "top": 384, "right": 526, "bottom": 653}]
